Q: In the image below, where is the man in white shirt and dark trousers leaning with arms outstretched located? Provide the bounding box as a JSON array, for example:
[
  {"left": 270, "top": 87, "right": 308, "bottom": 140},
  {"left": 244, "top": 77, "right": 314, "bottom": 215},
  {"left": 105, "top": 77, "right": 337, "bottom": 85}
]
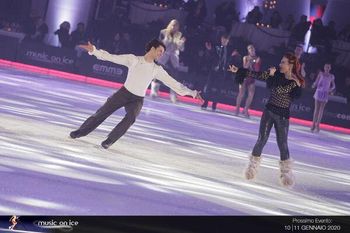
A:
[{"left": 70, "top": 39, "right": 203, "bottom": 149}]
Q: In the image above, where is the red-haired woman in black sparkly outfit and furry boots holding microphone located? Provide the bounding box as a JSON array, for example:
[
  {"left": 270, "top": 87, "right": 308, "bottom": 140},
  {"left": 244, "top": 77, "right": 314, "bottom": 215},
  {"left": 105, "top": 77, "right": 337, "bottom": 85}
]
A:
[{"left": 229, "top": 53, "right": 305, "bottom": 186}]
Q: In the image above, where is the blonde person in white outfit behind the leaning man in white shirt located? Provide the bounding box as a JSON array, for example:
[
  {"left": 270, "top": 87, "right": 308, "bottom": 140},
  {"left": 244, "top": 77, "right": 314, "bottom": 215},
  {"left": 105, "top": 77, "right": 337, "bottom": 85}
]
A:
[{"left": 151, "top": 19, "right": 188, "bottom": 103}]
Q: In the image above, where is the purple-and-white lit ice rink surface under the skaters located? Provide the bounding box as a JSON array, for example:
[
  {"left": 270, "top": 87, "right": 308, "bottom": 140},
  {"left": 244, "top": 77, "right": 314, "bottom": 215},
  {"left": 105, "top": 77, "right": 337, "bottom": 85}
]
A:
[{"left": 0, "top": 67, "right": 350, "bottom": 215}]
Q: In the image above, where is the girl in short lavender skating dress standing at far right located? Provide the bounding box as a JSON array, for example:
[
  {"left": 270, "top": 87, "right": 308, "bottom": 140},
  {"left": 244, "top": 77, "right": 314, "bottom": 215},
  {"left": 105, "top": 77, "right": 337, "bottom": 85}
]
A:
[{"left": 311, "top": 63, "right": 335, "bottom": 133}]
